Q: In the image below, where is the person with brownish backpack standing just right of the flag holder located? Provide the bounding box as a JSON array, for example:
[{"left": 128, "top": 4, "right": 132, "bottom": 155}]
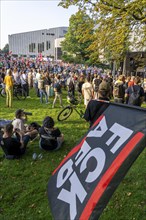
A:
[{"left": 113, "top": 75, "right": 126, "bottom": 103}]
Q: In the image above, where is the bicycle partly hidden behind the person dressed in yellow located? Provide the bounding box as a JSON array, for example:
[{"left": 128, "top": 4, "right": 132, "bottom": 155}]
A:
[{"left": 0, "top": 85, "right": 27, "bottom": 100}]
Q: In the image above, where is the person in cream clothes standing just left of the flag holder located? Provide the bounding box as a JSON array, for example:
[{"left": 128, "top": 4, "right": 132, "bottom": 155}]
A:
[{"left": 82, "top": 77, "right": 94, "bottom": 107}]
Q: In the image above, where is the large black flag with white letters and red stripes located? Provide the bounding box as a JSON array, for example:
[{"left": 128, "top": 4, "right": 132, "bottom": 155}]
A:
[{"left": 48, "top": 104, "right": 146, "bottom": 220}]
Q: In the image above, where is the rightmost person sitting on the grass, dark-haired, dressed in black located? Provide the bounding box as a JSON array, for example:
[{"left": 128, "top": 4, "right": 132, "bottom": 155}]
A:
[{"left": 39, "top": 116, "right": 64, "bottom": 151}]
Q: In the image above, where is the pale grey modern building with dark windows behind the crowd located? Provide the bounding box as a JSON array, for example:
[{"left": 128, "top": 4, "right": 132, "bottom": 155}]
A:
[{"left": 9, "top": 27, "right": 68, "bottom": 59}]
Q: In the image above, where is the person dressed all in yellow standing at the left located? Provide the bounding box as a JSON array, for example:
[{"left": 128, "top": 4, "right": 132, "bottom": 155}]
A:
[{"left": 4, "top": 69, "right": 13, "bottom": 108}]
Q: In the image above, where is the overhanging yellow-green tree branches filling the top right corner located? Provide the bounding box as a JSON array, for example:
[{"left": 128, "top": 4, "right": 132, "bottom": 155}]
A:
[{"left": 60, "top": 0, "right": 146, "bottom": 67}]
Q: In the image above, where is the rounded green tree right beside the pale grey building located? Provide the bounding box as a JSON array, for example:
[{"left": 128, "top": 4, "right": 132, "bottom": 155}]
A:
[{"left": 61, "top": 11, "right": 94, "bottom": 62}]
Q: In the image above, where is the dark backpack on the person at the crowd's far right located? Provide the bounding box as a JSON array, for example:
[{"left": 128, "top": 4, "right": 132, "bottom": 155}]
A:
[{"left": 128, "top": 86, "right": 141, "bottom": 106}]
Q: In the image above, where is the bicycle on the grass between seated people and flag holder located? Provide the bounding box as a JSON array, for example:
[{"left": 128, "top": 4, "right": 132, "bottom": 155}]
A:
[{"left": 57, "top": 95, "right": 84, "bottom": 121}]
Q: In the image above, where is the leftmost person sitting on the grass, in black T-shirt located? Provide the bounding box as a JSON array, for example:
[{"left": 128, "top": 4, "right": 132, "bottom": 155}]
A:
[{"left": 0, "top": 124, "right": 29, "bottom": 159}]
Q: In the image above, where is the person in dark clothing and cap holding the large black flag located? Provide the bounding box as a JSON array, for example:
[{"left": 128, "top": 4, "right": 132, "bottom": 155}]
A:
[{"left": 84, "top": 89, "right": 109, "bottom": 127}]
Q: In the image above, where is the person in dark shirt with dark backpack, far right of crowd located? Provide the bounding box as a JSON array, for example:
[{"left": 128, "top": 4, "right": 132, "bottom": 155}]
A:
[{"left": 125, "top": 76, "right": 144, "bottom": 106}]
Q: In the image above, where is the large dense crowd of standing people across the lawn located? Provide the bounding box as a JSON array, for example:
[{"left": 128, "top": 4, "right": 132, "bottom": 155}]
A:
[{"left": 0, "top": 54, "right": 146, "bottom": 108}]
